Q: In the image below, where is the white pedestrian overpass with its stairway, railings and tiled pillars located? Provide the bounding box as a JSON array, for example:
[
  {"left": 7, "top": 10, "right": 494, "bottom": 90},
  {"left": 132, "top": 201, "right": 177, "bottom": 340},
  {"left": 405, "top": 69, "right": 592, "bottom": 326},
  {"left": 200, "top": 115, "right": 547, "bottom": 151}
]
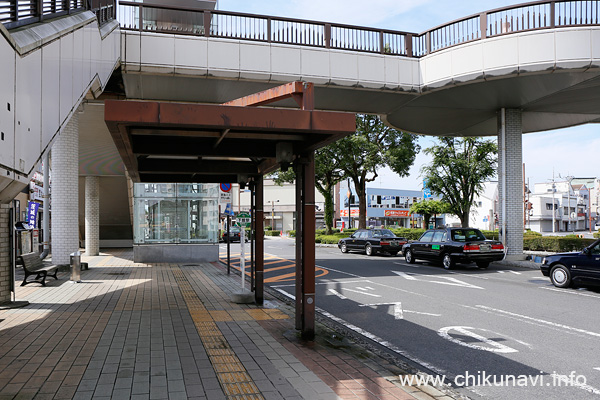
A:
[{"left": 0, "top": 0, "right": 600, "bottom": 338}]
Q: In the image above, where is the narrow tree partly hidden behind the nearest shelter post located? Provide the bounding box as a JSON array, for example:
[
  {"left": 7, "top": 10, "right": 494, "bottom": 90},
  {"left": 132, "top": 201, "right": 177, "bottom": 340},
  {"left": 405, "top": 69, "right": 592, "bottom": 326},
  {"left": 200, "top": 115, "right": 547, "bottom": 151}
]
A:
[{"left": 273, "top": 145, "right": 344, "bottom": 235}]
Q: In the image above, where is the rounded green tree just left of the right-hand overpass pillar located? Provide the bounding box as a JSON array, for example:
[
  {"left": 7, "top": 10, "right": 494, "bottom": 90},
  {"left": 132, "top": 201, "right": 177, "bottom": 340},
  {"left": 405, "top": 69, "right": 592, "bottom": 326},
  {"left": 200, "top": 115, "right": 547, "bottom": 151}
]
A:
[{"left": 421, "top": 137, "right": 498, "bottom": 227}]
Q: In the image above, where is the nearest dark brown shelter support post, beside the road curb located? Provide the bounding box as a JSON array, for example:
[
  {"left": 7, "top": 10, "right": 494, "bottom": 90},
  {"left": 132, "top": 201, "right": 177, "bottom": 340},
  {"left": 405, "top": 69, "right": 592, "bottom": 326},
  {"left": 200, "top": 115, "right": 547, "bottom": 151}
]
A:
[{"left": 295, "top": 152, "right": 315, "bottom": 340}]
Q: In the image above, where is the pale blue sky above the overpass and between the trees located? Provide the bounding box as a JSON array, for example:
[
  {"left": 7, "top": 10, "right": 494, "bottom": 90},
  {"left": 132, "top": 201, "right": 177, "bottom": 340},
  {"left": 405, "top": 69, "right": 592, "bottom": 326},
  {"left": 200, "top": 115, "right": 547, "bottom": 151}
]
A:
[{"left": 218, "top": 0, "right": 600, "bottom": 190}]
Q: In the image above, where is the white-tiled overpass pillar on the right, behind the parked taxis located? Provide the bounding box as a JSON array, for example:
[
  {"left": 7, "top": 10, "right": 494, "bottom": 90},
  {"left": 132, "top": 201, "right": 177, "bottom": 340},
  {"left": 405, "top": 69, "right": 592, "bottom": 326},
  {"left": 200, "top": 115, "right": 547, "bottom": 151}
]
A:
[{"left": 498, "top": 108, "right": 523, "bottom": 259}]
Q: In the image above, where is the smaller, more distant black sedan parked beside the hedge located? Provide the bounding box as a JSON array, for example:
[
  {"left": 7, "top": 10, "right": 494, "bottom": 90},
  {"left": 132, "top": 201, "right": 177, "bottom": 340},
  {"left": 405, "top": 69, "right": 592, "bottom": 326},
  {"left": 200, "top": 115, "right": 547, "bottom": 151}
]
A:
[{"left": 338, "top": 229, "right": 406, "bottom": 256}]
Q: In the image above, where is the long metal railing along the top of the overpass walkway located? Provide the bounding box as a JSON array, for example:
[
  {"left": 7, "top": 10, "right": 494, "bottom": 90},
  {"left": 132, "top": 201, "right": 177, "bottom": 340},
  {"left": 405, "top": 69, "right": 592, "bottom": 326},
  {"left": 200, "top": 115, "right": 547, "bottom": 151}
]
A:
[{"left": 118, "top": 0, "right": 600, "bottom": 57}]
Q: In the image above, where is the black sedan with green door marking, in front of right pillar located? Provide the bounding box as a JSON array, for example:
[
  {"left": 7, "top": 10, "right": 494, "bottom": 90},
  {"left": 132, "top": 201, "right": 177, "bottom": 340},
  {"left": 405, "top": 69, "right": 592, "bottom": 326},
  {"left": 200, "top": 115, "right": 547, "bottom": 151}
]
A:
[{"left": 402, "top": 228, "right": 504, "bottom": 269}]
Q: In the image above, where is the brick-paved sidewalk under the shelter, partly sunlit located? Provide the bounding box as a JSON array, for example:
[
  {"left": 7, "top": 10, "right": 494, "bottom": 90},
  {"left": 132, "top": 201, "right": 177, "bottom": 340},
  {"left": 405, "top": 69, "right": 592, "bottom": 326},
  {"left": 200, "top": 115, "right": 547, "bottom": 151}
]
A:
[{"left": 0, "top": 249, "right": 449, "bottom": 400}]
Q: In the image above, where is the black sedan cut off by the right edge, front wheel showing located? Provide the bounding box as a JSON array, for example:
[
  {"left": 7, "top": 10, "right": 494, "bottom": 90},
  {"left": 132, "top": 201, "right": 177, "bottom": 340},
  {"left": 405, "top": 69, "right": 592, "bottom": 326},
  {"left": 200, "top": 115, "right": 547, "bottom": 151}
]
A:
[{"left": 540, "top": 239, "right": 600, "bottom": 288}]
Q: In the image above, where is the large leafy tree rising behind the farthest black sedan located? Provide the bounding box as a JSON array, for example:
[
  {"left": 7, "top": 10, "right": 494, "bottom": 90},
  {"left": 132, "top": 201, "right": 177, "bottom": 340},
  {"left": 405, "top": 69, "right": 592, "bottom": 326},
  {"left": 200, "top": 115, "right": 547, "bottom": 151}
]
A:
[{"left": 331, "top": 114, "right": 420, "bottom": 228}]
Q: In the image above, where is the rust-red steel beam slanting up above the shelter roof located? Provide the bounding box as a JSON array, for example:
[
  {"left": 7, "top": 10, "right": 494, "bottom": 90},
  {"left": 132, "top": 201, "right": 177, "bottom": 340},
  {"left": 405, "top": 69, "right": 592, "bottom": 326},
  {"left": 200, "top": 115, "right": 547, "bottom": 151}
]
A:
[{"left": 223, "top": 81, "right": 315, "bottom": 110}]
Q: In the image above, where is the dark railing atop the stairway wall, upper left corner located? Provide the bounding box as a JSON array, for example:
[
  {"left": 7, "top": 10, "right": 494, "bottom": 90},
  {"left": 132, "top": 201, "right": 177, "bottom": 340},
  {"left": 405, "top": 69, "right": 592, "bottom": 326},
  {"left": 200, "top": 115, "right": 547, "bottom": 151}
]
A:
[{"left": 0, "top": 0, "right": 116, "bottom": 29}]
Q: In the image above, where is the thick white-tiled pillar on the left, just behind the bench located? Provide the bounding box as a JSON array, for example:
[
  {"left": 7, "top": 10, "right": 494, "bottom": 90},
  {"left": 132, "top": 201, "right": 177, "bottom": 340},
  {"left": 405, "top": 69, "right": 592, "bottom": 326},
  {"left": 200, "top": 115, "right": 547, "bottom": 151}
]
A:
[{"left": 51, "top": 112, "right": 79, "bottom": 264}]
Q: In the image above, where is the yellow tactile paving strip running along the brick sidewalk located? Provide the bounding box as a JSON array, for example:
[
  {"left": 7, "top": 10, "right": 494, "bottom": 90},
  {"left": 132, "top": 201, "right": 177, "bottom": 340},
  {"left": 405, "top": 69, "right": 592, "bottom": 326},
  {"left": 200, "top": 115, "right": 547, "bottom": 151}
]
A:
[{"left": 172, "top": 266, "right": 262, "bottom": 400}]
